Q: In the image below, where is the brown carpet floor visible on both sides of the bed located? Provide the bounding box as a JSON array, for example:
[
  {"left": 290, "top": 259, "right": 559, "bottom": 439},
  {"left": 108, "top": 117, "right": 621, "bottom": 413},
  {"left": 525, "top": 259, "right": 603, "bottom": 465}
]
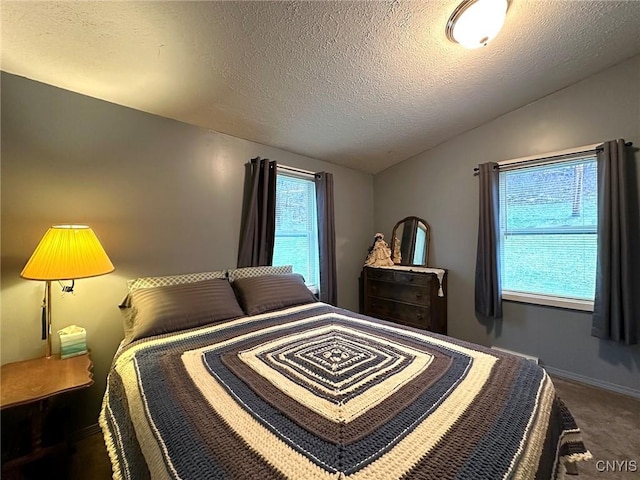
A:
[{"left": 57, "top": 377, "right": 640, "bottom": 480}]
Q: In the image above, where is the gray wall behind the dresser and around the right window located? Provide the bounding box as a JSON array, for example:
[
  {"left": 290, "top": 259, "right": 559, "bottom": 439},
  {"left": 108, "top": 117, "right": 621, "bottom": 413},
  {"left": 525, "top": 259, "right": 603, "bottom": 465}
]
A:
[{"left": 374, "top": 57, "right": 640, "bottom": 395}]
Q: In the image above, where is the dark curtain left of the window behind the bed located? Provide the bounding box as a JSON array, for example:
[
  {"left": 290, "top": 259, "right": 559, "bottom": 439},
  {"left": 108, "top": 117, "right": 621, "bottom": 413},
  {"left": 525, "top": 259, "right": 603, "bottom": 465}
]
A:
[{"left": 238, "top": 157, "right": 276, "bottom": 267}]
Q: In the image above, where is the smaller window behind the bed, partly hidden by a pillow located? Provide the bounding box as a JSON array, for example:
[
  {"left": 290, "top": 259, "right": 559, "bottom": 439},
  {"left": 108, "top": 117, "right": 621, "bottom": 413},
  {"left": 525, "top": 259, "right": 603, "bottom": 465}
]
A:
[{"left": 273, "top": 171, "right": 320, "bottom": 292}]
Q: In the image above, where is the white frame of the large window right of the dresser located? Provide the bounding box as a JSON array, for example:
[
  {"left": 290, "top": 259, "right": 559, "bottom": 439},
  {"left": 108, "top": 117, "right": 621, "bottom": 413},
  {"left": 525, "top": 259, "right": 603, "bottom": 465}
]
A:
[{"left": 498, "top": 151, "right": 599, "bottom": 312}]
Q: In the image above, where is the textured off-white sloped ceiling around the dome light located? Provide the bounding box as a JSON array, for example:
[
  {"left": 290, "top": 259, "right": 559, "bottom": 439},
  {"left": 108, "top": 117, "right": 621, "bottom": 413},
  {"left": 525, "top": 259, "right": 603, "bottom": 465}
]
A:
[{"left": 0, "top": 0, "right": 640, "bottom": 173}]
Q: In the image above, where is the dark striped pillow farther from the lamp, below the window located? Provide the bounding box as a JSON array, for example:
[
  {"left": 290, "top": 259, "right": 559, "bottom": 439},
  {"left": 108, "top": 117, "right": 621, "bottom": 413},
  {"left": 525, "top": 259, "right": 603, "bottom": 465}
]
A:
[{"left": 233, "top": 273, "right": 317, "bottom": 315}]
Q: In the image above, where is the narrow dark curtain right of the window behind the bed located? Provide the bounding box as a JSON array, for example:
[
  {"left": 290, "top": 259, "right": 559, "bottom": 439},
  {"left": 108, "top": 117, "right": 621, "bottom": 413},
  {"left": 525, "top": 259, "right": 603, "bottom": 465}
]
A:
[{"left": 315, "top": 172, "right": 338, "bottom": 305}]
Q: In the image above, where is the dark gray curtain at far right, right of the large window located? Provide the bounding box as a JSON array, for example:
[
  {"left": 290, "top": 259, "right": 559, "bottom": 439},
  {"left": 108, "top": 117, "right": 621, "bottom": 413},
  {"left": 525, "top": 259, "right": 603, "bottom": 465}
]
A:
[{"left": 591, "top": 140, "right": 640, "bottom": 345}]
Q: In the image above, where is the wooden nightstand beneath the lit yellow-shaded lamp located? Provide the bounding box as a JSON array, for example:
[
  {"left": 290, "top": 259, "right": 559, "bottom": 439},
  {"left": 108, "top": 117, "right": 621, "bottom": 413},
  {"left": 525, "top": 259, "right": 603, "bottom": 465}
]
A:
[{"left": 0, "top": 353, "right": 93, "bottom": 479}]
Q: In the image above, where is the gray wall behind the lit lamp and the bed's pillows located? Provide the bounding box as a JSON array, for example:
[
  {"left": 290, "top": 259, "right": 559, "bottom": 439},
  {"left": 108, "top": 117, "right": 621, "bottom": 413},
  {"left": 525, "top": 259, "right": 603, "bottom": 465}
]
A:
[{"left": 0, "top": 73, "right": 373, "bottom": 425}]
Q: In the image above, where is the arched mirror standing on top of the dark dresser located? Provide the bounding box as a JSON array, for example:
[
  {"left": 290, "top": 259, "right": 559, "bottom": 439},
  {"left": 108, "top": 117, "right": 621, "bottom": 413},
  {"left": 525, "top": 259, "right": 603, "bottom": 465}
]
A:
[{"left": 391, "top": 216, "right": 431, "bottom": 267}]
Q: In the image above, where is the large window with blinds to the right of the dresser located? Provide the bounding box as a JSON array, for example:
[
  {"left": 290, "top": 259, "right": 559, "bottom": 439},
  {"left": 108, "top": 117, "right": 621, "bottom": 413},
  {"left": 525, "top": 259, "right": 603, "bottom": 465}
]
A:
[{"left": 499, "top": 156, "right": 598, "bottom": 310}]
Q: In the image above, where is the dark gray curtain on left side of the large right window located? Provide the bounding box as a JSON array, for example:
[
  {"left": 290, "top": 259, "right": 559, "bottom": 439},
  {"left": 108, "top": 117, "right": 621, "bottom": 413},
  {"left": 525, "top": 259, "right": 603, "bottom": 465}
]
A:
[{"left": 475, "top": 162, "right": 502, "bottom": 319}]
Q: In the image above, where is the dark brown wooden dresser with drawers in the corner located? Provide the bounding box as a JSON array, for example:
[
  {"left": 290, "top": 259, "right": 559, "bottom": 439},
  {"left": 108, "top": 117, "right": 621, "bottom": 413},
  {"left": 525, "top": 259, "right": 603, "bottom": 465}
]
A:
[{"left": 362, "top": 267, "right": 447, "bottom": 335}]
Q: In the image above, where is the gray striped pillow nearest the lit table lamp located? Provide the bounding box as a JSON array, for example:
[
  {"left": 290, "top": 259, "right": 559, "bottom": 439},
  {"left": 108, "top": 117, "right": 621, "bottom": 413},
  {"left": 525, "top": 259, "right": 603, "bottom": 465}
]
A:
[{"left": 120, "top": 278, "right": 244, "bottom": 341}]
